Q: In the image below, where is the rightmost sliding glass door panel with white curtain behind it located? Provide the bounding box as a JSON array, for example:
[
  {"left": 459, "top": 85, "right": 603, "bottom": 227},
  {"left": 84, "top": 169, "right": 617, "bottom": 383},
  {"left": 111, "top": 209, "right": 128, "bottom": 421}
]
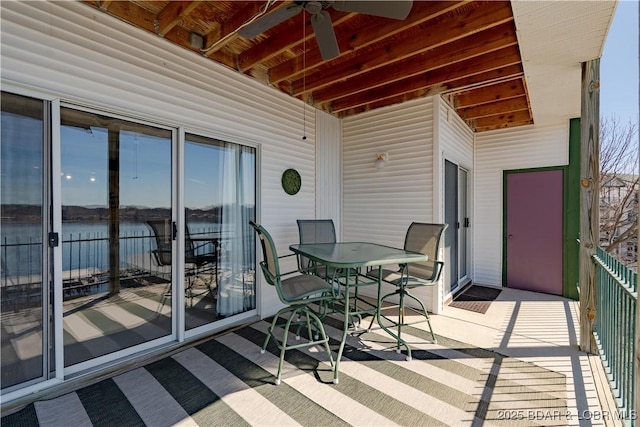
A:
[{"left": 184, "top": 134, "right": 256, "bottom": 330}]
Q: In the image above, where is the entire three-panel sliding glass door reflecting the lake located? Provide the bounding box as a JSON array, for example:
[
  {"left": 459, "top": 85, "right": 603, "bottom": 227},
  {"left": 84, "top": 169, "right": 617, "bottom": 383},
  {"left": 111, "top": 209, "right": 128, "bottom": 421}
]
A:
[{"left": 0, "top": 92, "right": 257, "bottom": 395}]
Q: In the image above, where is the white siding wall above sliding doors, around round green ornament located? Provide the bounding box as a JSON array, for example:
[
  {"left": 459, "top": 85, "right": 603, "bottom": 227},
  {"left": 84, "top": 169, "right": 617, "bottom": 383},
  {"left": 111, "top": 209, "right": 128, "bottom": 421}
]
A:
[{"left": 1, "top": 2, "right": 330, "bottom": 315}]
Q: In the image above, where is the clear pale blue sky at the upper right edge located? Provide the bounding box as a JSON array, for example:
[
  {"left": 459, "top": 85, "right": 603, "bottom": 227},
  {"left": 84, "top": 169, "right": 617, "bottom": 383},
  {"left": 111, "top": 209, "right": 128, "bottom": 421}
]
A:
[{"left": 600, "top": 0, "right": 640, "bottom": 124}]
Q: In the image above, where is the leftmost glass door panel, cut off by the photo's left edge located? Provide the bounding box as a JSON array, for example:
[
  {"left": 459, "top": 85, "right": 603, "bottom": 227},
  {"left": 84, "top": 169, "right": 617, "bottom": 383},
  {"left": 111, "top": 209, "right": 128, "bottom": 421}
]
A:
[{"left": 0, "top": 92, "right": 49, "bottom": 390}]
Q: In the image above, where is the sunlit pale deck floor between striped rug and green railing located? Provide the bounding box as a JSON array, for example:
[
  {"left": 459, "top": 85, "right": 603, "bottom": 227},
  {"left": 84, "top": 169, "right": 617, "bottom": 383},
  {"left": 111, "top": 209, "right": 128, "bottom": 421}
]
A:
[{"left": 425, "top": 288, "right": 623, "bottom": 426}]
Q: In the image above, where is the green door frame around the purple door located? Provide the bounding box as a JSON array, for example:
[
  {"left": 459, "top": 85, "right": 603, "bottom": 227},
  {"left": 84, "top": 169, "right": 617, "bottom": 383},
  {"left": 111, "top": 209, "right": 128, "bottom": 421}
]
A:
[{"left": 502, "top": 166, "right": 569, "bottom": 296}]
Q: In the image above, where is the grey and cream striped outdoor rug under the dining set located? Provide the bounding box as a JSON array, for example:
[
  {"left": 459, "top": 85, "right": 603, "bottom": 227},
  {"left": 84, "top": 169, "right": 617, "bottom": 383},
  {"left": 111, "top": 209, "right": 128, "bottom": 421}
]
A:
[{"left": 1, "top": 312, "right": 567, "bottom": 427}]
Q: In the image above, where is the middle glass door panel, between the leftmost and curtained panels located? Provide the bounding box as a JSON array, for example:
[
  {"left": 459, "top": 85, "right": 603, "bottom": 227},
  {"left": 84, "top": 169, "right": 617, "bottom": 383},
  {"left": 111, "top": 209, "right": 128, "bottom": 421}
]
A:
[{"left": 60, "top": 108, "right": 173, "bottom": 366}]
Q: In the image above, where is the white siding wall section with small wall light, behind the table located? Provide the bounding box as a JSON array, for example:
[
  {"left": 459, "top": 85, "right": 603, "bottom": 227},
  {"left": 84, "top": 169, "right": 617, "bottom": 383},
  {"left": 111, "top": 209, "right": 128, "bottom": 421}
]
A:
[{"left": 342, "top": 98, "right": 434, "bottom": 308}]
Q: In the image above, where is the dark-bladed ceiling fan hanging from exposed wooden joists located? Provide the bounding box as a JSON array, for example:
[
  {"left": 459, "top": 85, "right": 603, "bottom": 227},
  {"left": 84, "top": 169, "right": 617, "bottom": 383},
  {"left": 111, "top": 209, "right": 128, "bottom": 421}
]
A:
[{"left": 238, "top": 0, "right": 413, "bottom": 61}]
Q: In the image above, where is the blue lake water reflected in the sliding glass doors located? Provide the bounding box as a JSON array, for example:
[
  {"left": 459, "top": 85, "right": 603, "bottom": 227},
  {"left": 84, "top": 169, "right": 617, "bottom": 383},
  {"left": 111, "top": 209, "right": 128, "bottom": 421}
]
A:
[{"left": 0, "top": 222, "right": 220, "bottom": 278}]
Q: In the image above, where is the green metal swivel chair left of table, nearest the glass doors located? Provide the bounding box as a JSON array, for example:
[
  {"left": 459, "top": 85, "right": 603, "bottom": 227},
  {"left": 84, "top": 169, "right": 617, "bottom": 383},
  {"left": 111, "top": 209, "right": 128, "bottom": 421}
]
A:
[{"left": 249, "top": 221, "right": 335, "bottom": 385}]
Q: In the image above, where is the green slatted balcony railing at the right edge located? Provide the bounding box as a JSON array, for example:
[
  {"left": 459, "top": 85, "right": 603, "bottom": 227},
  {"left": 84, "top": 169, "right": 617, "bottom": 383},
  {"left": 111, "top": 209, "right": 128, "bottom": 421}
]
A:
[{"left": 593, "top": 248, "right": 639, "bottom": 425}]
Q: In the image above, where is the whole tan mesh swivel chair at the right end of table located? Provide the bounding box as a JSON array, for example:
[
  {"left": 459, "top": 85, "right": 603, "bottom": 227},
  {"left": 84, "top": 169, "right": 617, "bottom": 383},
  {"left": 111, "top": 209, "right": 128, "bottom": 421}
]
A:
[{"left": 367, "top": 222, "right": 448, "bottom": 360}]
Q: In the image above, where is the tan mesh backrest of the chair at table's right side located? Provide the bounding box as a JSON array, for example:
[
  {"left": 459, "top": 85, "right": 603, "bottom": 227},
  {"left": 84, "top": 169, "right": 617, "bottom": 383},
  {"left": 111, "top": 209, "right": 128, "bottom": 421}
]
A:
[{"left": 404, "top": 222, "right": 448, "bottom": 281}]
